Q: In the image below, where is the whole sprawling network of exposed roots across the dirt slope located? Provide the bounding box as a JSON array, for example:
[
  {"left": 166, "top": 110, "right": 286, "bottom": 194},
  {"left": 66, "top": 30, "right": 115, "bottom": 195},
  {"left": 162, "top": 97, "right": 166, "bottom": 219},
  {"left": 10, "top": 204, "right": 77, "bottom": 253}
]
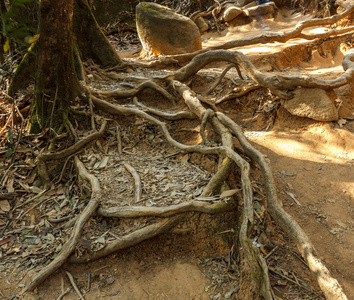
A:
[{"left": 0, "top": 1, "right": 354, "bottom": 299}]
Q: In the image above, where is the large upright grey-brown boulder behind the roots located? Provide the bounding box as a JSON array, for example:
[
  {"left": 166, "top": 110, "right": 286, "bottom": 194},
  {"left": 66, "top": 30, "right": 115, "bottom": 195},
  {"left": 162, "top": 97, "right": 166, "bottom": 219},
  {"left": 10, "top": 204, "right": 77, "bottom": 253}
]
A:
[{"left": 136, "top": 2, "right": 202, "bottom": 55}]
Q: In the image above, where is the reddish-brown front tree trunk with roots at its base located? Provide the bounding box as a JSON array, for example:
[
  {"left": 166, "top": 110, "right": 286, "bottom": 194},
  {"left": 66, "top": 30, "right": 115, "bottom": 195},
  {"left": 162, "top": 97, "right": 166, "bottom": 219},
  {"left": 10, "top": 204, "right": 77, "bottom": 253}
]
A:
[{"left": 29, "top": 0, "right": 80, "bottom": 132}]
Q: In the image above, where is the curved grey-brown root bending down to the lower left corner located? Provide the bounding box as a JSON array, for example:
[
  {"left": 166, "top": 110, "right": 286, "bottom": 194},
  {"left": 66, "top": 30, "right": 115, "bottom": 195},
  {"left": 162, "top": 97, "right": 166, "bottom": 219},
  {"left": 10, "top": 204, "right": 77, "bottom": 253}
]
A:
[{"left": 23, "top": 157, "right": 101, "bottom": 292}]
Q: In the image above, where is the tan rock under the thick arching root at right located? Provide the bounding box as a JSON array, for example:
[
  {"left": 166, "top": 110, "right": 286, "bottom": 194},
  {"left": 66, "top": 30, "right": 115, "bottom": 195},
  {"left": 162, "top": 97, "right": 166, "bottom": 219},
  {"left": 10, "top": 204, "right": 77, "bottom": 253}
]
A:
[{"left": 283, "top": 88, "right": 338, "bottom": 121}]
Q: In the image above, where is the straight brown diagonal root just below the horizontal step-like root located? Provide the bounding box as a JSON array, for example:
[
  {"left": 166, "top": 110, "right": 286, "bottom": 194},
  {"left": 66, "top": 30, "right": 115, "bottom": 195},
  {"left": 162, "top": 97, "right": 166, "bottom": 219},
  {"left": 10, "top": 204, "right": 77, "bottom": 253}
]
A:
[{"left": 69, "top": 216, "right": 183, "bottom": 263}]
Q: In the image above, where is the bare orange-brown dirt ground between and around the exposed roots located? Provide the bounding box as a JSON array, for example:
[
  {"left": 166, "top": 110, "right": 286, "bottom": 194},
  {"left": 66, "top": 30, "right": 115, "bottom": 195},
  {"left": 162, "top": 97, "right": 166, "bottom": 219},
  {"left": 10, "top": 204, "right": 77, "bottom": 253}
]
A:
[{"left": 0, "top": 10, "right": 354, "bottom": 300}]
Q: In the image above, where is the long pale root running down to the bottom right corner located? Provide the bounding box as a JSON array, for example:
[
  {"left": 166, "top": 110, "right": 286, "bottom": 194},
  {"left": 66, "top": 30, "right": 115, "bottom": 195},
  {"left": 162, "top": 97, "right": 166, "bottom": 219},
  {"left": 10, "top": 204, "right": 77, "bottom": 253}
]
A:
[{"left": 217, "top": 113, "right": 347, "bottom": 300}]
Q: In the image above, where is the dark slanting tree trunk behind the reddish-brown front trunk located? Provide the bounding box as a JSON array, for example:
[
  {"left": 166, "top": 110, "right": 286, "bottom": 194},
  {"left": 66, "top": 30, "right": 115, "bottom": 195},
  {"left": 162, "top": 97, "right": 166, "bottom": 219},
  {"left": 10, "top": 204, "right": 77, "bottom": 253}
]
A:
[{"left": 74, "top": 0, "right": 122, "bottom": 67}]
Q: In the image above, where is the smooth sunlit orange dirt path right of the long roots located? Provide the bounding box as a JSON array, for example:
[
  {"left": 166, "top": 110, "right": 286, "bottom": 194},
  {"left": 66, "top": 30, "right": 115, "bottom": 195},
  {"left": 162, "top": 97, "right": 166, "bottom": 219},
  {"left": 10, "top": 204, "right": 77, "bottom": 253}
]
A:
[{"left": 249, "top": 123, "right": 354, "bottom": 299}]
